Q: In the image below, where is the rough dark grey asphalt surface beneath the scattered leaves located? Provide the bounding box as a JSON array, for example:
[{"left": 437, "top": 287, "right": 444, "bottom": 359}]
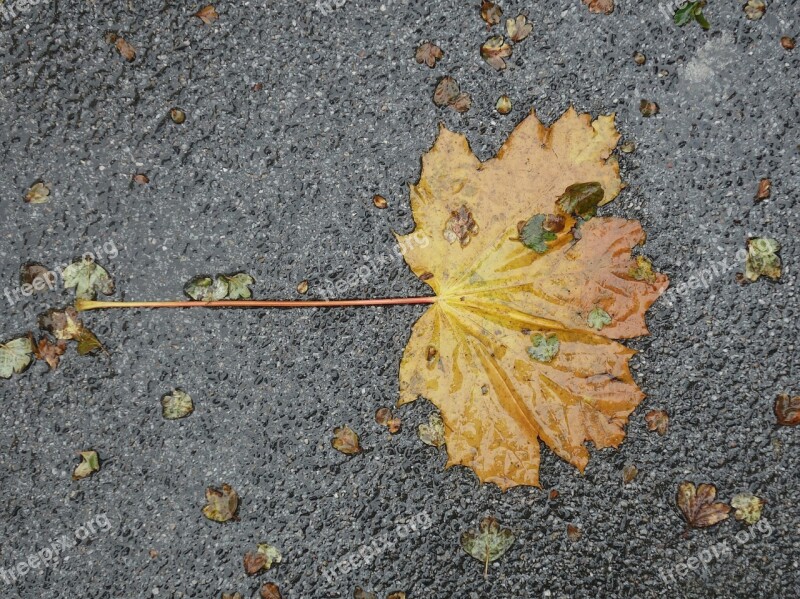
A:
[{"left": 0, "top": 0, "right": 800, "bottom": 599}]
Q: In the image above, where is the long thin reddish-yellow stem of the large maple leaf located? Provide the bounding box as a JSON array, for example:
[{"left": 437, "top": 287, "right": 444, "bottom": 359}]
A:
[{"left": 75, "top": 296, "right": 437, "bottom": 312}]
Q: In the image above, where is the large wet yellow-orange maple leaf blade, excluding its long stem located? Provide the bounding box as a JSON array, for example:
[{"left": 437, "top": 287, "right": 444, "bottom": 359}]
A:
[{"left": 397, "top": 108, "right": 668, "bottom": 489}]
